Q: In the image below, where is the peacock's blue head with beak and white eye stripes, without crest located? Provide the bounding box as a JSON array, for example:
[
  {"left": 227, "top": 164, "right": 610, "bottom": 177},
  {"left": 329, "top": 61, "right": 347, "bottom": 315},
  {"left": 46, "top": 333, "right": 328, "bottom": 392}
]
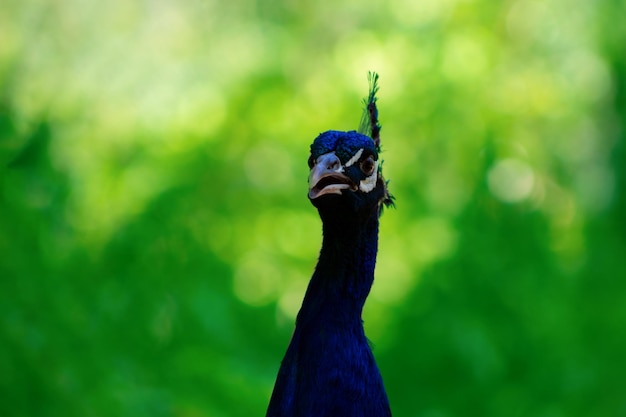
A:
[{"left": 309, "top": 130, "right": 392, "bottom": 211}]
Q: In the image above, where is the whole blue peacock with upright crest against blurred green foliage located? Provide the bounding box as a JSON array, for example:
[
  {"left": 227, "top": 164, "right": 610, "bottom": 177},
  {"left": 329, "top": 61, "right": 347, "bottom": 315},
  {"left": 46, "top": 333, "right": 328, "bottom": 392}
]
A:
[{"left": 267, "top": 73, "right": 393, "bottom": 417}]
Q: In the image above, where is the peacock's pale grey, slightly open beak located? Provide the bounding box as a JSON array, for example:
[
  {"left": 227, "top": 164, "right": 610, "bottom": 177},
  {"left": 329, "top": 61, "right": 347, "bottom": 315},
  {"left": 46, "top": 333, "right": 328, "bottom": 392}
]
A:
[{"left": 309, "top": 152, "right": 357, "bottom": 200}]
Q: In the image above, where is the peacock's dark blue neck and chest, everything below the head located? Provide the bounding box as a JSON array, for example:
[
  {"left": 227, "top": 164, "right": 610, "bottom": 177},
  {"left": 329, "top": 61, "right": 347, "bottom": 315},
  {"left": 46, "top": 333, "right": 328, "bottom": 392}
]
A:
[{"left": 267, "top": 208, "right": 391, "bottom": 417}]
